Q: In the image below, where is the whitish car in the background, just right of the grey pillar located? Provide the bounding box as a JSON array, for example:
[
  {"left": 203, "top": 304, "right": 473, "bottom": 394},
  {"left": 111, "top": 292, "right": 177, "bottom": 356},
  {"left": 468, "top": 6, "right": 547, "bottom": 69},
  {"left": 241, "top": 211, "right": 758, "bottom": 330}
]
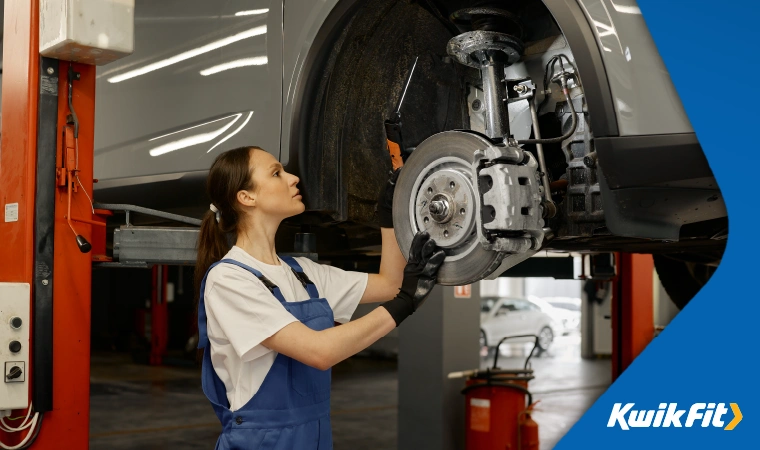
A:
[{"left": 480, "top": 297, "right": 562, "bottom": 352}]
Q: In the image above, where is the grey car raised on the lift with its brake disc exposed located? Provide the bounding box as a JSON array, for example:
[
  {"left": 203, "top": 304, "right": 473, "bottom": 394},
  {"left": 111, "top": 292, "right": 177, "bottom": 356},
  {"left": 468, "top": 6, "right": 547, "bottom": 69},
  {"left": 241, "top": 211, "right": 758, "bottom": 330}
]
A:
[{"left": 94, "top": 0, "right": 728, "bottom": 306}]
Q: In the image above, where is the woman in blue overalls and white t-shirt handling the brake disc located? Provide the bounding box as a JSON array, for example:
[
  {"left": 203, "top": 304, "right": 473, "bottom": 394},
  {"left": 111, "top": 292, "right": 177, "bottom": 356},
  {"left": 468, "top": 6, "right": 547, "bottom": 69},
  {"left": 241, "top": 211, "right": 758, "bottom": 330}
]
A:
[{"left": 195, "top": 147, "right": 445, "bottom": 449}]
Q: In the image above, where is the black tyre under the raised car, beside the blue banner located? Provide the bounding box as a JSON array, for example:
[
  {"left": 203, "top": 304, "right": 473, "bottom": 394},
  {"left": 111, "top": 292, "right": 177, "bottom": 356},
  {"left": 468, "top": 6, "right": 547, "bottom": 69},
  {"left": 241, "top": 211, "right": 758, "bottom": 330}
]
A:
[{"left": 652, "top": 255, "right": 716, "bottom": 309}]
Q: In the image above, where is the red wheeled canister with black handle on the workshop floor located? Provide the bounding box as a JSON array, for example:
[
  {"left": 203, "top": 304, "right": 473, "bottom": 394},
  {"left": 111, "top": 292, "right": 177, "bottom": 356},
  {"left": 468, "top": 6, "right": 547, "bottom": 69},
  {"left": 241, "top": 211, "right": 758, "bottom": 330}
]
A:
[{"left": 448, "top": 335, "right": 539, "bottom": 450}]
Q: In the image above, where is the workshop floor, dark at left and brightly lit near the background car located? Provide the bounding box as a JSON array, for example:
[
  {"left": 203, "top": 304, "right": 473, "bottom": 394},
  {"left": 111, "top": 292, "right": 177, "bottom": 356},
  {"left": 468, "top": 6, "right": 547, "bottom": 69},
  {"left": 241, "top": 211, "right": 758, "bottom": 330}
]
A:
[{"left": 90, "top": 336, "right": 610, "bottom": 450}]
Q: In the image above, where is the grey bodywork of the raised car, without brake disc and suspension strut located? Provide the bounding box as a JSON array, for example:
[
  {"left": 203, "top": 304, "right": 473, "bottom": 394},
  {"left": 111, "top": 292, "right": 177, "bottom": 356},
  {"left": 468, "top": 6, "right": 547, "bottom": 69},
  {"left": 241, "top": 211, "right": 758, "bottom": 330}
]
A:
[{"left": 95, "top": 0, "right": 727, "bottom": 302}]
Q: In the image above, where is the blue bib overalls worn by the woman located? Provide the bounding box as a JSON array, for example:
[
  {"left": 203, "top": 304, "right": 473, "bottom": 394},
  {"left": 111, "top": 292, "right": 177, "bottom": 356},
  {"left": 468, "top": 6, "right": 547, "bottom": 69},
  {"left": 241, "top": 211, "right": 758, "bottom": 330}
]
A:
[{"left": 198, "top": 257, "right": 334, "bottom": 450}]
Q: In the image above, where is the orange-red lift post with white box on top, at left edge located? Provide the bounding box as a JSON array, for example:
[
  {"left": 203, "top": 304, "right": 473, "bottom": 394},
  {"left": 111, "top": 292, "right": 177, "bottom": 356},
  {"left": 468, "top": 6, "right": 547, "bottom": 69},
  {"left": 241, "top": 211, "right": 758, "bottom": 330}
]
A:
[{"left": 0, "top": 0, "right": 134, "bottom": 449}]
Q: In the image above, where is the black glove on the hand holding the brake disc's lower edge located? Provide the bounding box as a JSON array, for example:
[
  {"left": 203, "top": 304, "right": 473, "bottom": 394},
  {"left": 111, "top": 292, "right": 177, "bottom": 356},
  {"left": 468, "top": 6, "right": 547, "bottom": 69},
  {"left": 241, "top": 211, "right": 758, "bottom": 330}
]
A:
[{"left": 380, "top": 231, "right": 446, "bottom": 326}]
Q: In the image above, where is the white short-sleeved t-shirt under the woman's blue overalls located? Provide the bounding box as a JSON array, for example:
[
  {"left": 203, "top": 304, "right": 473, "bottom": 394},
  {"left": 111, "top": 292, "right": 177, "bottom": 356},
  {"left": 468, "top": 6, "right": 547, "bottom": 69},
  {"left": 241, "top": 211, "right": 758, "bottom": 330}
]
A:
[{"left": 204, "top": 246, "right": 367, "bottom": 411}]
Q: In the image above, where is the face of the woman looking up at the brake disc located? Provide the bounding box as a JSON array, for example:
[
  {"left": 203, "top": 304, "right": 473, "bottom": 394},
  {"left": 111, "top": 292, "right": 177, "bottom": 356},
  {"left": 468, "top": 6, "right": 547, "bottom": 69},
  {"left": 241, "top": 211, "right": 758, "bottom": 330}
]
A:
[{"left": 249, "top": 150, "right": 306, "bottom": 219}]
